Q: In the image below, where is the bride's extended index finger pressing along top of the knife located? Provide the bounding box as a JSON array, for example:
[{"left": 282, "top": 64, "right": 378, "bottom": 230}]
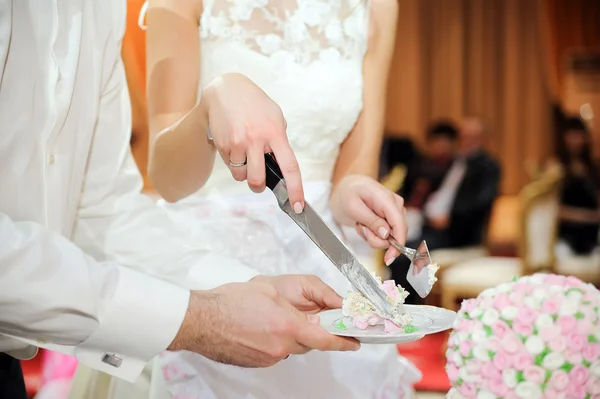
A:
[{"left": 269, "top": 139, "right": 304, "bottom": 213}]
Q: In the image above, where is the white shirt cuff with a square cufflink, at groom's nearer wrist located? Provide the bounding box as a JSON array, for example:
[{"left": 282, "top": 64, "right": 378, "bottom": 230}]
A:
[{"left": 74, "top": 267, "right": 190, "bottom": 382}]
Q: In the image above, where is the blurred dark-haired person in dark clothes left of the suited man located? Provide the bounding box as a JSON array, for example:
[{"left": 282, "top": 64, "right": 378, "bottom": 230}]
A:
[{"left": 399, "top": 122, "right": 458, "bottom": 240}]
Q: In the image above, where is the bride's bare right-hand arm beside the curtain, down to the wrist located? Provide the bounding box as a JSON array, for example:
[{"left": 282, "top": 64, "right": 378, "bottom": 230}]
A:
[{"left": 333, "top": 0, "right": 398, "bottom": 187}]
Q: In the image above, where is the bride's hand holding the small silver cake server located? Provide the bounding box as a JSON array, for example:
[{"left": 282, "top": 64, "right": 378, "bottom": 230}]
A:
[{"left": 331, "top": 175, "right": 408, "bottom": 264}]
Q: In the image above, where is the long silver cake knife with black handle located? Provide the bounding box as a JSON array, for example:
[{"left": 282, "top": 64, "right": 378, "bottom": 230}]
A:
[{"left": 265, "top": 154, "right": 394, "bottom": 319}]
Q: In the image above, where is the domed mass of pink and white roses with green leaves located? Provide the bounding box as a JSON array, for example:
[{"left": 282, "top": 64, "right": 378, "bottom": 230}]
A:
[{"left": 446, "top": 274, "right": 600, "bottom": 399}]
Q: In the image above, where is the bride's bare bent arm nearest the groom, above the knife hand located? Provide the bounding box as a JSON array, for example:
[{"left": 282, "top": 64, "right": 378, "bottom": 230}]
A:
[{"left": 146, "top": 0, "right": 215, "bottom": 201}]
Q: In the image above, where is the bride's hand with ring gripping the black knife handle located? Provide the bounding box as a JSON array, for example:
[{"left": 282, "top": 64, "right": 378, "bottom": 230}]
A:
[{"left": 202, "top": 74, "right": 304, "bottom": 212}]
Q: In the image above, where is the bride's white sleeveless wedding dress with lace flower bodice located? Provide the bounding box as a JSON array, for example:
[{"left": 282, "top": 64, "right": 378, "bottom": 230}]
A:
[{"left": 149, "top": 0, "right": 420, "bottom": 399}]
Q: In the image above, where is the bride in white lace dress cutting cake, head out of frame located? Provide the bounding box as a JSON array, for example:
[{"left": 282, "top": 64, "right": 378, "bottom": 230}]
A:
[{"left": 71, "top": 0, "right": 420, "bottom": 399}]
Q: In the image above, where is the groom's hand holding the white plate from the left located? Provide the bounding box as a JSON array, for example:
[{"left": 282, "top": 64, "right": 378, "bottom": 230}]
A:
[{"left": 169, "top": 277, "right": 360, "bottom": 367}]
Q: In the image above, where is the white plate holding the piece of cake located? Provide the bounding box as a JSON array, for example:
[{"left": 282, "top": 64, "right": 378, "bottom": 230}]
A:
[{"left": 319, "top": 305, "right": 456, "bottom": 344}]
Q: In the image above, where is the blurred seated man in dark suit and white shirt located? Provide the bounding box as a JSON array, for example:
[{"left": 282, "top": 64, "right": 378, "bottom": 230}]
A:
[{"left": 391, "top": 118, "right": 500, "bottom": 303}]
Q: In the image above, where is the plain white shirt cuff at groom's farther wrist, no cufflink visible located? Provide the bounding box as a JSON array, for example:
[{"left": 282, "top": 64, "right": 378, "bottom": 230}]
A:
[{"left": 185, "top": 253, "right": 260, "bottom": 290}]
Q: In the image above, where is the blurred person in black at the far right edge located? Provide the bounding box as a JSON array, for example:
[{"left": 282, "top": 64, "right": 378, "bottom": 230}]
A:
[{"left": 556, "top": 117, "right": 600, "bottom": 256}]
